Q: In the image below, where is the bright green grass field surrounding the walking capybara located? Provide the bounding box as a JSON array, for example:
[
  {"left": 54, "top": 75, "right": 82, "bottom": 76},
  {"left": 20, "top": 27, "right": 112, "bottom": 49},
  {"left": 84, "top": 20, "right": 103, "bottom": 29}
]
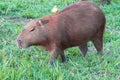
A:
[{"left": 0, "top": 0, "right": 120, "bottom": 80}]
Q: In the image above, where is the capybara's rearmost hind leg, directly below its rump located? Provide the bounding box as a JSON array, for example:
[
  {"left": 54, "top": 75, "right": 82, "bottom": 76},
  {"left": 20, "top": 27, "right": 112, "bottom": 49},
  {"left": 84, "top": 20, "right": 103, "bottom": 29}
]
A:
[{"left": 92, "top": 38, "right": 103, "bottom": 55}]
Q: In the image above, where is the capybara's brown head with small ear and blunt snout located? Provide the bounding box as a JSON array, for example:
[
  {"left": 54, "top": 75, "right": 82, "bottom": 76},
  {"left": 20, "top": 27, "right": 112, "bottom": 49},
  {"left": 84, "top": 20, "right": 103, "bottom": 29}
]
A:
[{"left": 17, "top": 19, "right": 48, "bottom": 48}]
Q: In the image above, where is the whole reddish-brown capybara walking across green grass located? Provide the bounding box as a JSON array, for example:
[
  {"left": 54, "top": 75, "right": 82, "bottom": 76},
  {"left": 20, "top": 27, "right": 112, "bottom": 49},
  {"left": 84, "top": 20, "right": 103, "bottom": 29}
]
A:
[{"left": 17, "top": 1, "right": 106, "bottom": 64}]
